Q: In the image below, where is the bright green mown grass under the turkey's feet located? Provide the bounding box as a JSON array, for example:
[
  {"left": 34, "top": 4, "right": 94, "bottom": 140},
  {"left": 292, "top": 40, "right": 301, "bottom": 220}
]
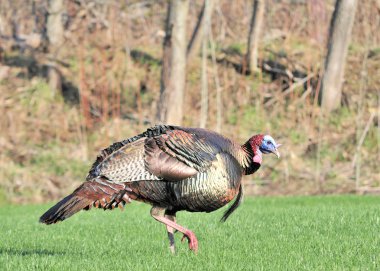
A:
[{"left": 0, "top": 196, "right": 380, "bottom": 271}]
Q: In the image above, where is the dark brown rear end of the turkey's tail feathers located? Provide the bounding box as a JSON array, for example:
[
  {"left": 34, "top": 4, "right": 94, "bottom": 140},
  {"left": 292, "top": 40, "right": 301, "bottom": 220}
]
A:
[{"left": 40, "top": 196, "right": 92, "bottom": 225}]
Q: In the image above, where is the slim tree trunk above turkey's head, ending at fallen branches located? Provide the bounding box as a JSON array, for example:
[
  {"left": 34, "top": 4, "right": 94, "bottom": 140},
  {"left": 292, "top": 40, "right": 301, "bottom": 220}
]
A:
[{"left": 243, "top": 0, "right": 265, "bottom": 71}]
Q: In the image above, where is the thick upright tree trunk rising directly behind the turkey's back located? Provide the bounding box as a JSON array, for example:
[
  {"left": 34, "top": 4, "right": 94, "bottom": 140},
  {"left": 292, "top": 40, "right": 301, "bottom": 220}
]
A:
[{"left": 157, "top": 0, "right": 189, "bottom": 125}]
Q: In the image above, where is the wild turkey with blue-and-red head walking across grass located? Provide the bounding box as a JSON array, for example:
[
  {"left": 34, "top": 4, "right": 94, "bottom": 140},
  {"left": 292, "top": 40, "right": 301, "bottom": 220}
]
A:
[{"left": 40, "top": 125, "right": 279, "bottom": 253}]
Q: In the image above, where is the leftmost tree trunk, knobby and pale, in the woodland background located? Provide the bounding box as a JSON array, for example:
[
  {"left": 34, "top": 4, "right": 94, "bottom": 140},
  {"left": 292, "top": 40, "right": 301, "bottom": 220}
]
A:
[{"left": 46, "top": 0, "right": 64, "bottom": 95}]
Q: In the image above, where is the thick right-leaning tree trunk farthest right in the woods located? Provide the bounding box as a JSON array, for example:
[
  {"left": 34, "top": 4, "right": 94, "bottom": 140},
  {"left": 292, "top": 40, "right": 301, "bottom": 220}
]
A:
[{"left": 321, "top": 0, "right": 357, "bottom": 112}]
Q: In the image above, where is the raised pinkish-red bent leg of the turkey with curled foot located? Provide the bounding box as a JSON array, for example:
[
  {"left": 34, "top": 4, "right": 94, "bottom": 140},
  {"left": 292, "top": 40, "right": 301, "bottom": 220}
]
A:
[{"left": 150, "top": 207, "right": 198, "bottom": 253}]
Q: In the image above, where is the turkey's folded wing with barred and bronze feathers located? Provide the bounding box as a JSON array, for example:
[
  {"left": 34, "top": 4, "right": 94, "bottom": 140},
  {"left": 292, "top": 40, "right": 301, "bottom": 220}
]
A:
[{"left": 88, "top": 126, "right": 228, "bottom": 183}]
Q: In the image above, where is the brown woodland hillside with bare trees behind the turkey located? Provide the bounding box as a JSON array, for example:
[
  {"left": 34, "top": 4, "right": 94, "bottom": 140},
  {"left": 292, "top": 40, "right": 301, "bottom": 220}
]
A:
[{"left": 0, "top": 0, "right": 380, "bottom": 204}]
